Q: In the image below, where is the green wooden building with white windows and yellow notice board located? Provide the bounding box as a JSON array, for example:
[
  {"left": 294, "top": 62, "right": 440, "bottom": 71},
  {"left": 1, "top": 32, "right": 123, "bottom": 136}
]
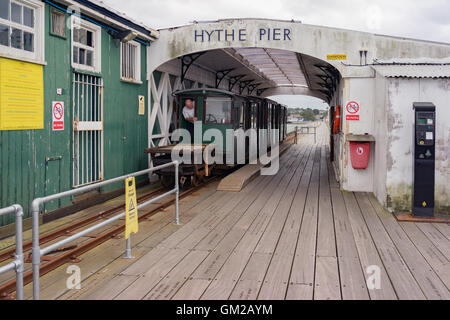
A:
[{"left": 0, "top": 0, "right": 158, "bottom": 230}]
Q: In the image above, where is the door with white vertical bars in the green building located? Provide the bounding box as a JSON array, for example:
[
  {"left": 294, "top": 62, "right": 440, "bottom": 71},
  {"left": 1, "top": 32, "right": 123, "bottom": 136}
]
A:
[{"left": 72, "top": 73, "right": 104, "bottom": 187}]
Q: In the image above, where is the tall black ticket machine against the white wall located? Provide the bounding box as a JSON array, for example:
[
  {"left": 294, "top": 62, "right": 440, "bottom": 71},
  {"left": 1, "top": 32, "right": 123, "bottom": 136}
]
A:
[{"left": 413, "top": 102, "right": 436, "bottom": 217}]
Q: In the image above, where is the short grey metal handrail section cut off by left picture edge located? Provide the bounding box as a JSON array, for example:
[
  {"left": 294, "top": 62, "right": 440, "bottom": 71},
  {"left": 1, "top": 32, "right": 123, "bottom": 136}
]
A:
[{"left": 0, "top": 204, "right": 24, "bottom": 300}]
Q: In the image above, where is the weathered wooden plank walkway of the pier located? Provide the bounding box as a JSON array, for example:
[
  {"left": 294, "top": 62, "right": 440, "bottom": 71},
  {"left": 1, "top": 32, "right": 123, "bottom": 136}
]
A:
[{"left": 46, "top": 122, "right": 450, "bottom": 300}]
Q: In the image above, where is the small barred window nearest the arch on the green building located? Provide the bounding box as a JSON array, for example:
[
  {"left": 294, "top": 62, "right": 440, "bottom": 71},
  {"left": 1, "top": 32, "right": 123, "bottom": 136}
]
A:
[{"left": 120, "top": 41, "right": 141, "bottom": 82}]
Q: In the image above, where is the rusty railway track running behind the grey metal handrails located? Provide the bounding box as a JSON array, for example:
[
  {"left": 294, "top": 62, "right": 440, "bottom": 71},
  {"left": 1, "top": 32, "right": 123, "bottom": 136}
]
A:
[{"left": 0, "top": 176, "right": 220, "bottom": 300}]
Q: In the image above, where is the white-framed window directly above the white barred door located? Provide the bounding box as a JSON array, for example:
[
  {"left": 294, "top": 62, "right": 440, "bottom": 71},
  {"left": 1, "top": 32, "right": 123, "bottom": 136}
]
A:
[{"left": 72, "top": 17, "right": 101, "bottom": 72}]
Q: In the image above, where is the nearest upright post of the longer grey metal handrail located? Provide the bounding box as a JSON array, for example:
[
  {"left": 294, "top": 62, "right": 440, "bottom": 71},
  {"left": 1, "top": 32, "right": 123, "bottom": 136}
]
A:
[{"left": 31, "top": 198, "right": 41, "bottom": 300}]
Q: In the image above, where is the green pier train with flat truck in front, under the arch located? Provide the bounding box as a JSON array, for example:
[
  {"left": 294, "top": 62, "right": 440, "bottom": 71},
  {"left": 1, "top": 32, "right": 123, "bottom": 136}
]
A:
[{"left": 146, "top": 88, "right": 286, "bottom": 186}]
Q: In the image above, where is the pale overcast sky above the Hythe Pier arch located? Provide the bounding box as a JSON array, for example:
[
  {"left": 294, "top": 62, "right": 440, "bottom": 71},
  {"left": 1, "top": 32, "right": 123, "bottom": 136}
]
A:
[{"left": 103, "top": 0, "right": 450, "bottom": 109}]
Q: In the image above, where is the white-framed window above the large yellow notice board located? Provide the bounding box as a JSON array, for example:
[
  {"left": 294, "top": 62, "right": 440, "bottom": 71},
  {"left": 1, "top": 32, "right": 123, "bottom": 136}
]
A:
[{"left": 0, "top": 0, "right": 36, "bottom": 53}]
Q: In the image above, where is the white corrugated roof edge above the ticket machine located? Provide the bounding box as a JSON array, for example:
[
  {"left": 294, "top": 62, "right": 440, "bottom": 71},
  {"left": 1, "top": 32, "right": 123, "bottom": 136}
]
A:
[{"left": 372, "top": 64, "right": 450, "bottom": 78}]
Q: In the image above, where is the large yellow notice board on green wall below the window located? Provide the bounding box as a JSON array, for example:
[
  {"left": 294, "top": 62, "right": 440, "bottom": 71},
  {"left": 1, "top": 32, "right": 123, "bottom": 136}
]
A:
[{"left": 0, "top": 58, "right": 44, "bottom": 130}]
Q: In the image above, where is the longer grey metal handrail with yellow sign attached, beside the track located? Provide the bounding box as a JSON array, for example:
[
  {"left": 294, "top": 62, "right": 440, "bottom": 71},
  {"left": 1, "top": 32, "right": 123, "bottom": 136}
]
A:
[{"left": 31, "top": 161, "right": 180, "bottom": 300}]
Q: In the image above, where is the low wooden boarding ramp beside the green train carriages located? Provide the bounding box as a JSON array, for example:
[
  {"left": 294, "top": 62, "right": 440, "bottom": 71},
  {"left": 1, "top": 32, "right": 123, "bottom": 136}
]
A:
[{"left": 217, "top": 142, "right": 292, "bottom": 192}]
